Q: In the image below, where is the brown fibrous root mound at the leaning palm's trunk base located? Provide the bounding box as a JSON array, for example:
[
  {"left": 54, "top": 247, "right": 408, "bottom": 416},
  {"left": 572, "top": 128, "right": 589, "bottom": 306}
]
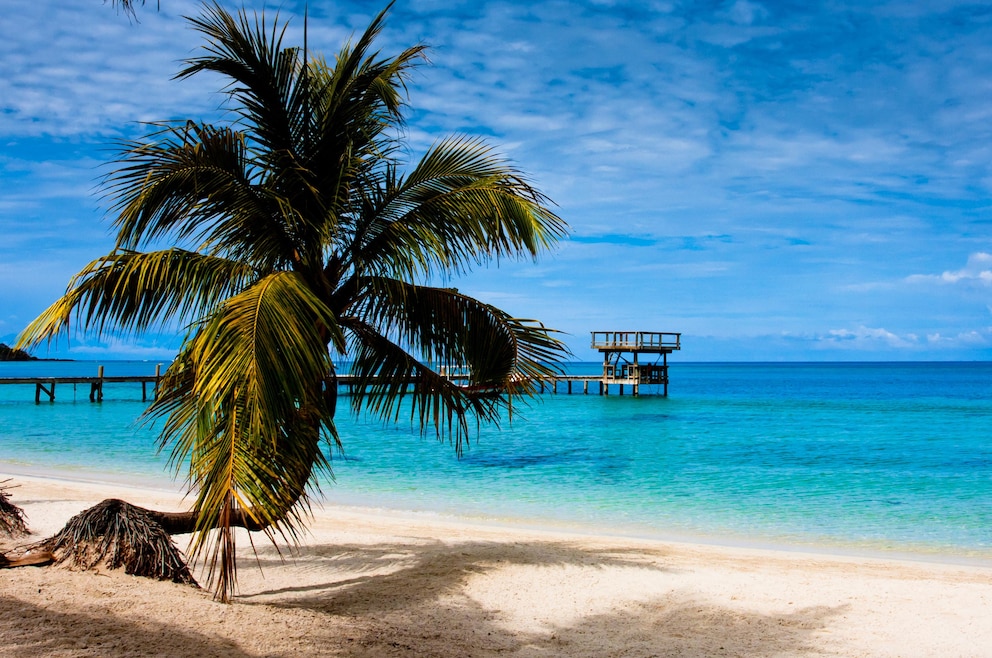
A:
[{"left": 35, "top": 498, "right": 198, "bottom": 587}]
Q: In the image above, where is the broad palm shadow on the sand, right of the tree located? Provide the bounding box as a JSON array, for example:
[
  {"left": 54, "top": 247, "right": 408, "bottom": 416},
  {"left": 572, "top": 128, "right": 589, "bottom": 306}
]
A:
[{"left": 239, "top": 541, "right": 842, "bottom": 658}]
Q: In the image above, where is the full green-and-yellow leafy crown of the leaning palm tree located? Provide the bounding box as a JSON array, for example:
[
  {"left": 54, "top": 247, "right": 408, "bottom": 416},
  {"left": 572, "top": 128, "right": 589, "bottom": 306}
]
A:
[{"left": 18, "top": 4, "right": 566, "bottom": 600}]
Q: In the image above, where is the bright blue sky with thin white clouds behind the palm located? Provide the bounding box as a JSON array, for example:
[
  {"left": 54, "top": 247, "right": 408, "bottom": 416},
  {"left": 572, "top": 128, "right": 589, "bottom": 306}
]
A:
[{"left": 0, "top": 0, "right": 992, "bottom": 361}]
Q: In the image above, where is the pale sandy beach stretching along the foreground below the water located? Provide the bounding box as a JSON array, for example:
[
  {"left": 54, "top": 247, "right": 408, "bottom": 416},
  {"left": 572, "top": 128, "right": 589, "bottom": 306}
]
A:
[{"left": 0, "top": 468, "right": 992, "bottom": 657}]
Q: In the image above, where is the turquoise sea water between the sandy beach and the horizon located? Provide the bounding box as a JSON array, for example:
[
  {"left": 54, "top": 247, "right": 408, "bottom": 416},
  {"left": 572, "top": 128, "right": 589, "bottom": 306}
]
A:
[{"left": 0, "top": 362, "right": 992, "bottom": 561}]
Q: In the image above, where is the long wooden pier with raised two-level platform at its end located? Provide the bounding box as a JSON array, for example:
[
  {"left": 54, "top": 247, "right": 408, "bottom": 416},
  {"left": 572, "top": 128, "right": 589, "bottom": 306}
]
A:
[{"left": 0, "top": 331, "right": 681, "bottom": 404}]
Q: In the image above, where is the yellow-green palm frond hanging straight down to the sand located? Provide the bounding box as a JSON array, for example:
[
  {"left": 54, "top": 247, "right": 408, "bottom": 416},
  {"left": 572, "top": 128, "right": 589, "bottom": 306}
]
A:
[{"left": 149, "top": 272, "right": 343, "bottom": 591}]
